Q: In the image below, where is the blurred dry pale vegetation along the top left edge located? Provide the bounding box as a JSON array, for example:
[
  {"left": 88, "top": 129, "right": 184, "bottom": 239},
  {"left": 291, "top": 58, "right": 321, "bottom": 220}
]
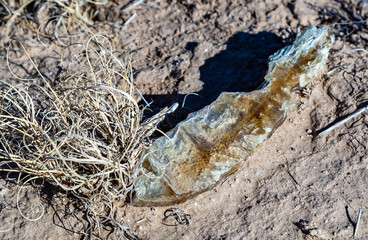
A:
[{"left": 0, "top": 0, "right": 142, "bottom": 42}]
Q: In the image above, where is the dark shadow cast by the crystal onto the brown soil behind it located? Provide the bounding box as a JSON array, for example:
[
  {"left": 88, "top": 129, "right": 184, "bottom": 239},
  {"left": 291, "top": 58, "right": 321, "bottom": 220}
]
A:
[{"left": 144, "top": 32, "right": 284, "bottom": 131}]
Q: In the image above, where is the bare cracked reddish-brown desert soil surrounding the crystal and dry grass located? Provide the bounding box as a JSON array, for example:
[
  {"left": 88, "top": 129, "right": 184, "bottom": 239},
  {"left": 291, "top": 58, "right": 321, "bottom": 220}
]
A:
[{"left": 0, "top": 0, "right": 368, "bottom": 240}]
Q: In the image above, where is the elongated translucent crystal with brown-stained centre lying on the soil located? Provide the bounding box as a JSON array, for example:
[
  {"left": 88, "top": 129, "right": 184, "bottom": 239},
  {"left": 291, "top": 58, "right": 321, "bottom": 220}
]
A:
[{"left": 133, "top": 26, "right": 334, "bottom": 206}]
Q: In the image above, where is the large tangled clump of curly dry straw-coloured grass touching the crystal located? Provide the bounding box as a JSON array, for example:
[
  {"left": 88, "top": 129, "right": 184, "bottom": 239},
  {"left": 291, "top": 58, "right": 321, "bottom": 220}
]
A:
[{"left": 0, "top": 33, "right": 168, "bottom": 238}]
